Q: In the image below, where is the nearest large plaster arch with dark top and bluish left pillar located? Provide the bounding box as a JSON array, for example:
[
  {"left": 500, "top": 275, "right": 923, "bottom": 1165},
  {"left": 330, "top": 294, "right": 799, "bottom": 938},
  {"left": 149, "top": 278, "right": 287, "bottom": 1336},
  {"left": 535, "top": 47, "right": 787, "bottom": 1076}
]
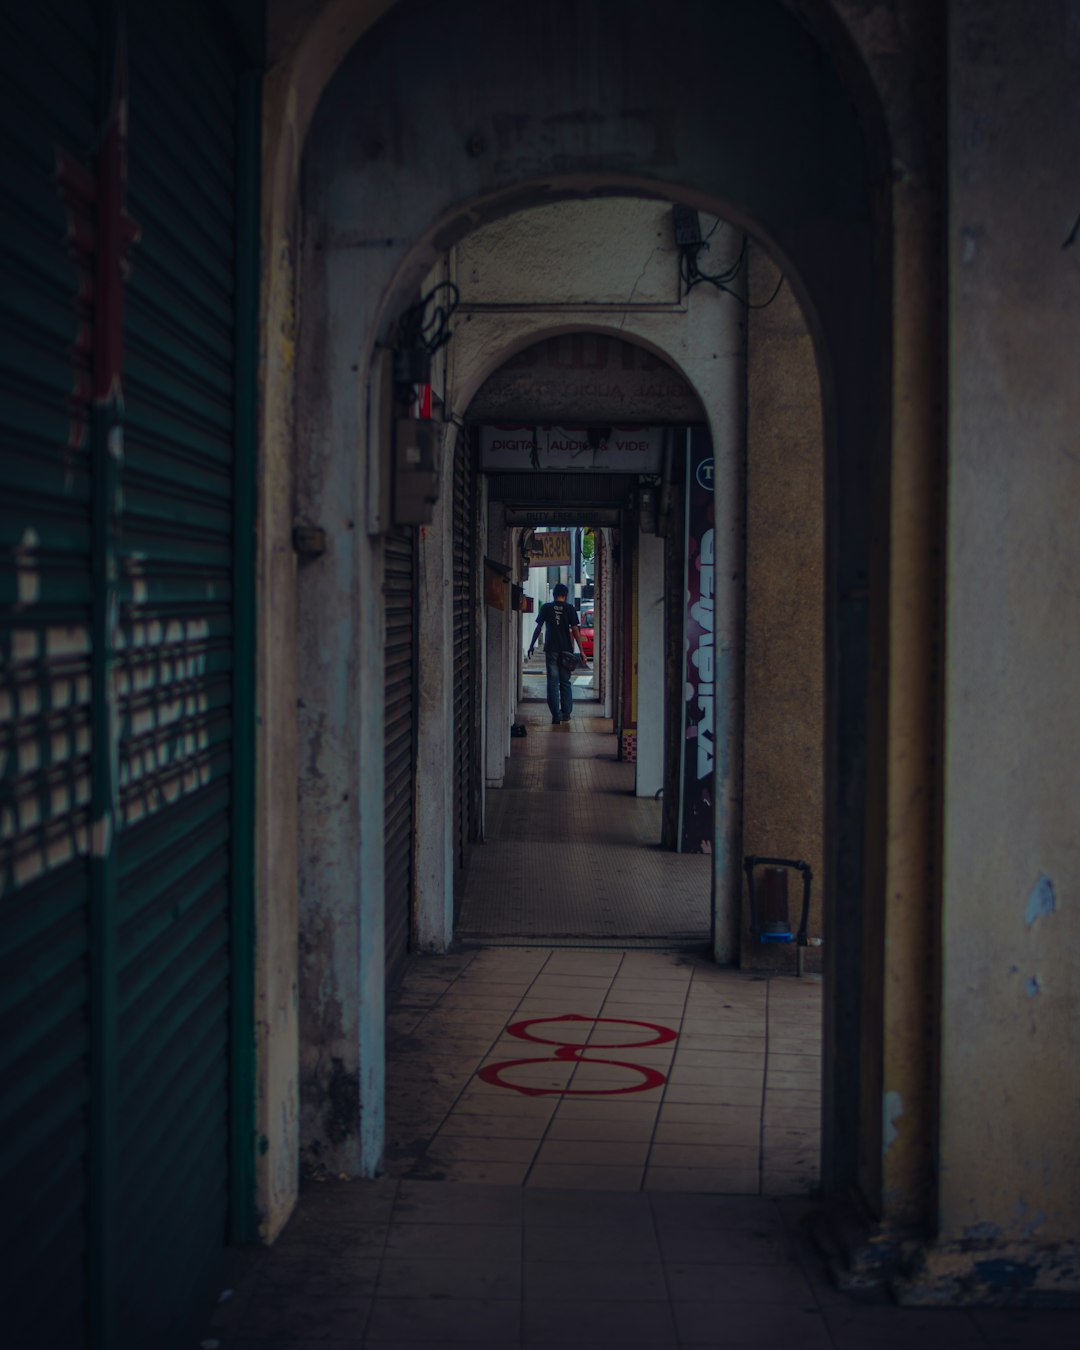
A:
[{"left": 263, "top": 3, "right": 888, "bottom": 1236}]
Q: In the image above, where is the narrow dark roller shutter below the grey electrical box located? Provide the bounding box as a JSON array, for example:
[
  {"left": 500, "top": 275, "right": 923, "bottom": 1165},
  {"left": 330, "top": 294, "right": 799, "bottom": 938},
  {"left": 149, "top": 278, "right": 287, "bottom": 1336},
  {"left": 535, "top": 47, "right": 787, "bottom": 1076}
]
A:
[{"left": 383, "top": 527, "right": 416, "bottom": 992}]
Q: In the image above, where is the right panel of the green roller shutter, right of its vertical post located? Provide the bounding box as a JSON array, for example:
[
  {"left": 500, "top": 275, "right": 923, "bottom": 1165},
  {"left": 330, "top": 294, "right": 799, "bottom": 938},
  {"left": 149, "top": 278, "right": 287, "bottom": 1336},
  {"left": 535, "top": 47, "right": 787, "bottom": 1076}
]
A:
[{"left": 115, "top": 0, "right": 236, "bottom": 1328}]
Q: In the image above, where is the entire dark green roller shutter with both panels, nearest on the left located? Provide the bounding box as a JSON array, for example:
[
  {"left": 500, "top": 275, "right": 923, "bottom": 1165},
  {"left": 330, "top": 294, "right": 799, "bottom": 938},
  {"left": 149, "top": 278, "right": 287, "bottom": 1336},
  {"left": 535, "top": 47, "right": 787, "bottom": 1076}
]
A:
[{"left": 0, "top": 0, "right": 258, "bottom": 1350}]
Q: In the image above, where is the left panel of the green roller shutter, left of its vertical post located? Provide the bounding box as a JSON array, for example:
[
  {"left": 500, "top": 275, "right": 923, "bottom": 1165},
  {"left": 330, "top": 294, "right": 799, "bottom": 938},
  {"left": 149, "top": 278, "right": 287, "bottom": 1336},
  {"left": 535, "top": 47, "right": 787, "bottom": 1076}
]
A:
[{"left": 0, "top": 3, "right": 99, "bottom": 1350}]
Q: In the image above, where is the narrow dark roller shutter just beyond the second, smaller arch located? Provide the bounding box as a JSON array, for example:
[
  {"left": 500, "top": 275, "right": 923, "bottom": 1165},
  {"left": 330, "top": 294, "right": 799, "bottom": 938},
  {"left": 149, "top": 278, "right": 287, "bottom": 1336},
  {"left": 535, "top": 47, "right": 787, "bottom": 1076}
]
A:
[{"left": 454, "top": 435, "right": 478, "bottom": 907}]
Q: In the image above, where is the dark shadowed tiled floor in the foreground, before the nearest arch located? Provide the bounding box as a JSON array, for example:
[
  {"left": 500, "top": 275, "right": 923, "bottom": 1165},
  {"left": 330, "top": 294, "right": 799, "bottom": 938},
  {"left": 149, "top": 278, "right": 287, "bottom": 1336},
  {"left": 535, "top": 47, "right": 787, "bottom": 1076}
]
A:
[{"left": 206, "top": 1179, "right": 1080, "bottom": 1350}]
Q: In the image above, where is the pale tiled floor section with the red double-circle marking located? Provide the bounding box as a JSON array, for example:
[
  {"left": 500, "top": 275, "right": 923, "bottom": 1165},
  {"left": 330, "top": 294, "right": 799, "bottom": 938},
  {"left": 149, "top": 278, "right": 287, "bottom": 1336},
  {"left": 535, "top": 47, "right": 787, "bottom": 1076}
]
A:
[{"left": 387, "top": 948, "right": 821, "bottom": 1195}]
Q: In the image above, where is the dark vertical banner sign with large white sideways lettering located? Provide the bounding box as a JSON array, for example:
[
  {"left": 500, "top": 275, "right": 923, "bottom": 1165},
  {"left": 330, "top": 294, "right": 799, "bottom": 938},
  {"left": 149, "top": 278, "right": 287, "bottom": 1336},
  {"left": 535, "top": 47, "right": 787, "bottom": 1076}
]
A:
[{"left": 679, "top": 427, "right": 716, "bottom": 853}]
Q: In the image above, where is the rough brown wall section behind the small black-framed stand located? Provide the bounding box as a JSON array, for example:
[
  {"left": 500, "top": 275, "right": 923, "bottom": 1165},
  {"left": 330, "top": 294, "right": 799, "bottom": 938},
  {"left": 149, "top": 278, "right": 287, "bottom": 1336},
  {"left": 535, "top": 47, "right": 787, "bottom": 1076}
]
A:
[{"left": 740, "top": 248, "right": 829, "bottom": 972}]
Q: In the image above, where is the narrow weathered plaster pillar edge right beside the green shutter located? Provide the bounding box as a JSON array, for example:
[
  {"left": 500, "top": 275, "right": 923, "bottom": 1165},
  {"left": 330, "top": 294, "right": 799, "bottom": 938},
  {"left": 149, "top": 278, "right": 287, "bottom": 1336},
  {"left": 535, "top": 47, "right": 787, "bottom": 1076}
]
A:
[{"left": 255, "top": 0, "right": 392, "bottom": 1241}]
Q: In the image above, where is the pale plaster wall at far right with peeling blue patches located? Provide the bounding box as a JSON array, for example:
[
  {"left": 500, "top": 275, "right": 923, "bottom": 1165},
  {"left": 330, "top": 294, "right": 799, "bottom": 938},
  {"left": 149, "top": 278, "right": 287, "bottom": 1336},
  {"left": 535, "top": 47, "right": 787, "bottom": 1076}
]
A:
[{"left": 918, "top": 0, "right": 1080, "bottom": 1295}]
